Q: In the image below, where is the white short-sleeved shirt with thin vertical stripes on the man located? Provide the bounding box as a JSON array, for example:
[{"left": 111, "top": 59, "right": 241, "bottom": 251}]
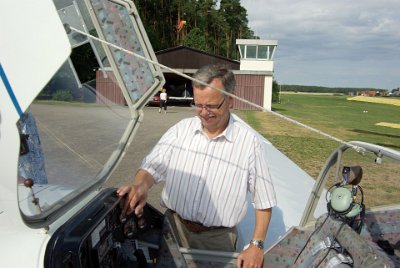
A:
[{"left": 141, "top": 115, "right": 276, "bottom": 227}]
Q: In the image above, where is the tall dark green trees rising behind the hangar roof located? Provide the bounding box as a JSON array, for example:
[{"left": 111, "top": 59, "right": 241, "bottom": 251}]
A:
[{"left": 134, "top": 0, "right": 258, "bottom": 59}]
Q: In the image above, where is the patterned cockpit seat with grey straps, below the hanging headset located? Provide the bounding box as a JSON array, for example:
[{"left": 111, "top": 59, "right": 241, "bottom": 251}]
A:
[{"left": 264, "top": 214, "right": 395, "bottom": 268}]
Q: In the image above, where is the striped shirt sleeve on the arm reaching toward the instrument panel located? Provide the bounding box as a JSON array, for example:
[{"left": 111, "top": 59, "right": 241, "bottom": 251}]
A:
[{"left": 140, "top": 122, "right": 178, "bottom": 183}]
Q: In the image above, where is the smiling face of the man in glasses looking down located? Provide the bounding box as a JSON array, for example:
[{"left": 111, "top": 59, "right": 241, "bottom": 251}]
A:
[{"left": 193, "top": 79, "right": 232, "bottom": 135}]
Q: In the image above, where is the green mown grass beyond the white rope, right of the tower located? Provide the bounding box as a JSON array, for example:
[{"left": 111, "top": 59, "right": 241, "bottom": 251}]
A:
[{"left": 273, "top": 94, "right": 400, "bottom": 149}]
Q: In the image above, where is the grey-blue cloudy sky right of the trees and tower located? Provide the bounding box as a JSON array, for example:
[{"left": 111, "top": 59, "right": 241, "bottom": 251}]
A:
[{"left": 241, "top": 0, "right": 400, "bottom": 90}]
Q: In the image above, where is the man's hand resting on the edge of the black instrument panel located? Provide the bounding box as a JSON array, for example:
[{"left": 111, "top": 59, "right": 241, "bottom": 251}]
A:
[{"left": 117, "top": 170, "right": 154, "bottom": 219}]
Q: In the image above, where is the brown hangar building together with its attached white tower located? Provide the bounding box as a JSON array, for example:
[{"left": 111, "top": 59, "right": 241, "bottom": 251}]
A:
[{"left": 96, "top": 39, "right": 277, "bottom": 110}]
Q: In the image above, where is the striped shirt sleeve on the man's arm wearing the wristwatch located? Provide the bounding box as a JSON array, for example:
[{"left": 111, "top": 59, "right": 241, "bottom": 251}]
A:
[{"left": 249, "top": 137, "right": 277, "bottom": 209}]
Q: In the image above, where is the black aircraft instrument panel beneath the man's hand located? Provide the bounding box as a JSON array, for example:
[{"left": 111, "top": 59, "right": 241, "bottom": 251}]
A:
[{"left": 44, "top": 189, "right": 164, "bottom": 268}]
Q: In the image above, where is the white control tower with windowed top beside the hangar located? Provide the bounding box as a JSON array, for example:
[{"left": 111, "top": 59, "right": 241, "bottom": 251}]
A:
[{"left": 236, "top": 39, "right": 278, "bottom": 111}]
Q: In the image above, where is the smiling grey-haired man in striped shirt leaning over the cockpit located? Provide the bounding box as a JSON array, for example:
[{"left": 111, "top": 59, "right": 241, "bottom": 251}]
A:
[{"left": 117, "top": 65, "right": 276, "bottom": 267}]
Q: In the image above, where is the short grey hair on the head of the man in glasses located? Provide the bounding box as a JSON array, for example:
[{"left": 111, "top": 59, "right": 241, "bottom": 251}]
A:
[{"left": 192, "top": 64, "right": 236, "bottom": 93}]
